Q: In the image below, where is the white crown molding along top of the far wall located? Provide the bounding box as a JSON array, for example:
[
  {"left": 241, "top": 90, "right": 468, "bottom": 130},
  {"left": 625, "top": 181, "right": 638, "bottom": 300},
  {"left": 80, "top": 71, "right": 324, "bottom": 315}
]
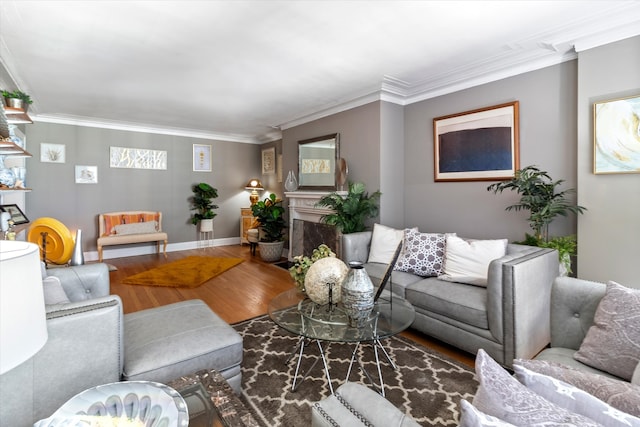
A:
[{"left": 31, "top": 114, "right": 264, "bottom": 144}]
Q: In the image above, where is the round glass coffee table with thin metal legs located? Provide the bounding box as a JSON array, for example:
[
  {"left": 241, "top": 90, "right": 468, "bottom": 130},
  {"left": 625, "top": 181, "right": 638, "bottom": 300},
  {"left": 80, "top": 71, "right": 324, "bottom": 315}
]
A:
[{"left": 269, "top": 288, "right": 415, "bottom": 396}]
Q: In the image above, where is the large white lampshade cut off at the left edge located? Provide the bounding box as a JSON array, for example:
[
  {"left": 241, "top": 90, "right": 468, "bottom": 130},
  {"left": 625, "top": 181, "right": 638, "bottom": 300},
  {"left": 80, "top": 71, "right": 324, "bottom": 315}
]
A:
[{"left": 0, "top": 240, "right": 48, "bottom": 374}]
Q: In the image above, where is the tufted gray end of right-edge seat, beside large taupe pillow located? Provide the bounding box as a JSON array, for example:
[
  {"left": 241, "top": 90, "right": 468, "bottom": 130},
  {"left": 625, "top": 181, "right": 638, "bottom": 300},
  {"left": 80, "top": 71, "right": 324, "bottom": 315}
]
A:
[{"left": 551, "top": 277, "right": 607, "bottom": 350}]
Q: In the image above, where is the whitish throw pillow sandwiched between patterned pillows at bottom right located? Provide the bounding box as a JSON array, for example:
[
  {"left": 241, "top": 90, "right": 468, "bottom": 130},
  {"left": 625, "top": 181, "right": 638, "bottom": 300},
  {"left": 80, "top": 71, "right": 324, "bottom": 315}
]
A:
[{"left": 513, "top": 365, "right": 640, "bottom": 427}]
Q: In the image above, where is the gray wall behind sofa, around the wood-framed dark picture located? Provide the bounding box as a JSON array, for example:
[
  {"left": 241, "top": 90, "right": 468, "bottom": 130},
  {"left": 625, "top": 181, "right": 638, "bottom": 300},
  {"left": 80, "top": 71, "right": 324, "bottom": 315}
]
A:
[{"left": 404, "top": 61, "right": 577, "bottom": 241}]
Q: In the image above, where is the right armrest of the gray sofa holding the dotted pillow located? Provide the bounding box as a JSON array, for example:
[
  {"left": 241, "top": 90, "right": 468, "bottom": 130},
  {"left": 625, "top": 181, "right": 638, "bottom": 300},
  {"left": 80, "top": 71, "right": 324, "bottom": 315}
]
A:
[{"left": 487, "top": 247, "right": 559, "bottom": 366}]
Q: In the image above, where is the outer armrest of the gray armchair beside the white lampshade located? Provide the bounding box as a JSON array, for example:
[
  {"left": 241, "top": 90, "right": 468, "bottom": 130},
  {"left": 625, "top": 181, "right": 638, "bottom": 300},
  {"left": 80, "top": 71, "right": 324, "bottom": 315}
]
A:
[{"left": 0, "top": 295, "right": 122, "bottom": 426}]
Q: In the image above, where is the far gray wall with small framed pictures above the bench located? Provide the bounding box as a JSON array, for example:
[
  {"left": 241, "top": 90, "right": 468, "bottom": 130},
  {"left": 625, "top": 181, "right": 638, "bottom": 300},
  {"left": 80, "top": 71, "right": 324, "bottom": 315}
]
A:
[{"left": 25, "top": 123, "right": 266, "bottom": 251}]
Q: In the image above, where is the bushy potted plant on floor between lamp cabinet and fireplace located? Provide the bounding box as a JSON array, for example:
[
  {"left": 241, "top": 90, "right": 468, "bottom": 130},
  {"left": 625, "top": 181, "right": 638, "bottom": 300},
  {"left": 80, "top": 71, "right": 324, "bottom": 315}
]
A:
[{"left": 251, "top": 193, "right": 287, "bottom": 262}]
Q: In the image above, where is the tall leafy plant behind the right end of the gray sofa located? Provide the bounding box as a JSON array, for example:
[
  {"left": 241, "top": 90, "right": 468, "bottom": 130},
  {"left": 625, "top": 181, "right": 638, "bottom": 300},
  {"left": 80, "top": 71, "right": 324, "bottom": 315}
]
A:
[{"left": 487, "top": 166, "right": 587, "bottom": 274}]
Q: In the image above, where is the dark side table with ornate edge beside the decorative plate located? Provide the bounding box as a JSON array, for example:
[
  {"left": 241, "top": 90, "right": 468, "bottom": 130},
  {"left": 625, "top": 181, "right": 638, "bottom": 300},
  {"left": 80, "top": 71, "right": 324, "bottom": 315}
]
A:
[{"left": 167, "top": 369, "right": 260, "bottom": 427}]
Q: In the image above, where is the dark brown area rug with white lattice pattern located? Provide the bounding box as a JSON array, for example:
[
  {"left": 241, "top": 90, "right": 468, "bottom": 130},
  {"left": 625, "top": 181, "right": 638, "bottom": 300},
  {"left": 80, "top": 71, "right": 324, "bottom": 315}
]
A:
[{"left": 233, "top": 316, "right": 478, "bottom": 426}]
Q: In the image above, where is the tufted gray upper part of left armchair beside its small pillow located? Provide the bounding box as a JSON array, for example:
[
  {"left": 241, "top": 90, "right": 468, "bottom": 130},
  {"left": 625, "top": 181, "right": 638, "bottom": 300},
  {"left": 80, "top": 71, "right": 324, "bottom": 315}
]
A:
[{"left": 47, "top": 263, "right": 110, "bottom": 302}]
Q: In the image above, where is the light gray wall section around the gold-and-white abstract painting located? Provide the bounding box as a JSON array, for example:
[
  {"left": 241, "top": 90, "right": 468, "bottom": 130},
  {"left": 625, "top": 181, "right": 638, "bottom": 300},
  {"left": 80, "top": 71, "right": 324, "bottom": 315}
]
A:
[{"left": 577, "top": 37, "right": 640, "bottom": 288}]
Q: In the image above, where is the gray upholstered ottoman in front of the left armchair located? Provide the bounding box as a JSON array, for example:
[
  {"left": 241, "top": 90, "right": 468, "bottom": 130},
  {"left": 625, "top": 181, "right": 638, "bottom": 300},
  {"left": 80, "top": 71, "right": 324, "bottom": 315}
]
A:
[{"left": 122, "top": 300, "right": 242, "bottom": 394}]
